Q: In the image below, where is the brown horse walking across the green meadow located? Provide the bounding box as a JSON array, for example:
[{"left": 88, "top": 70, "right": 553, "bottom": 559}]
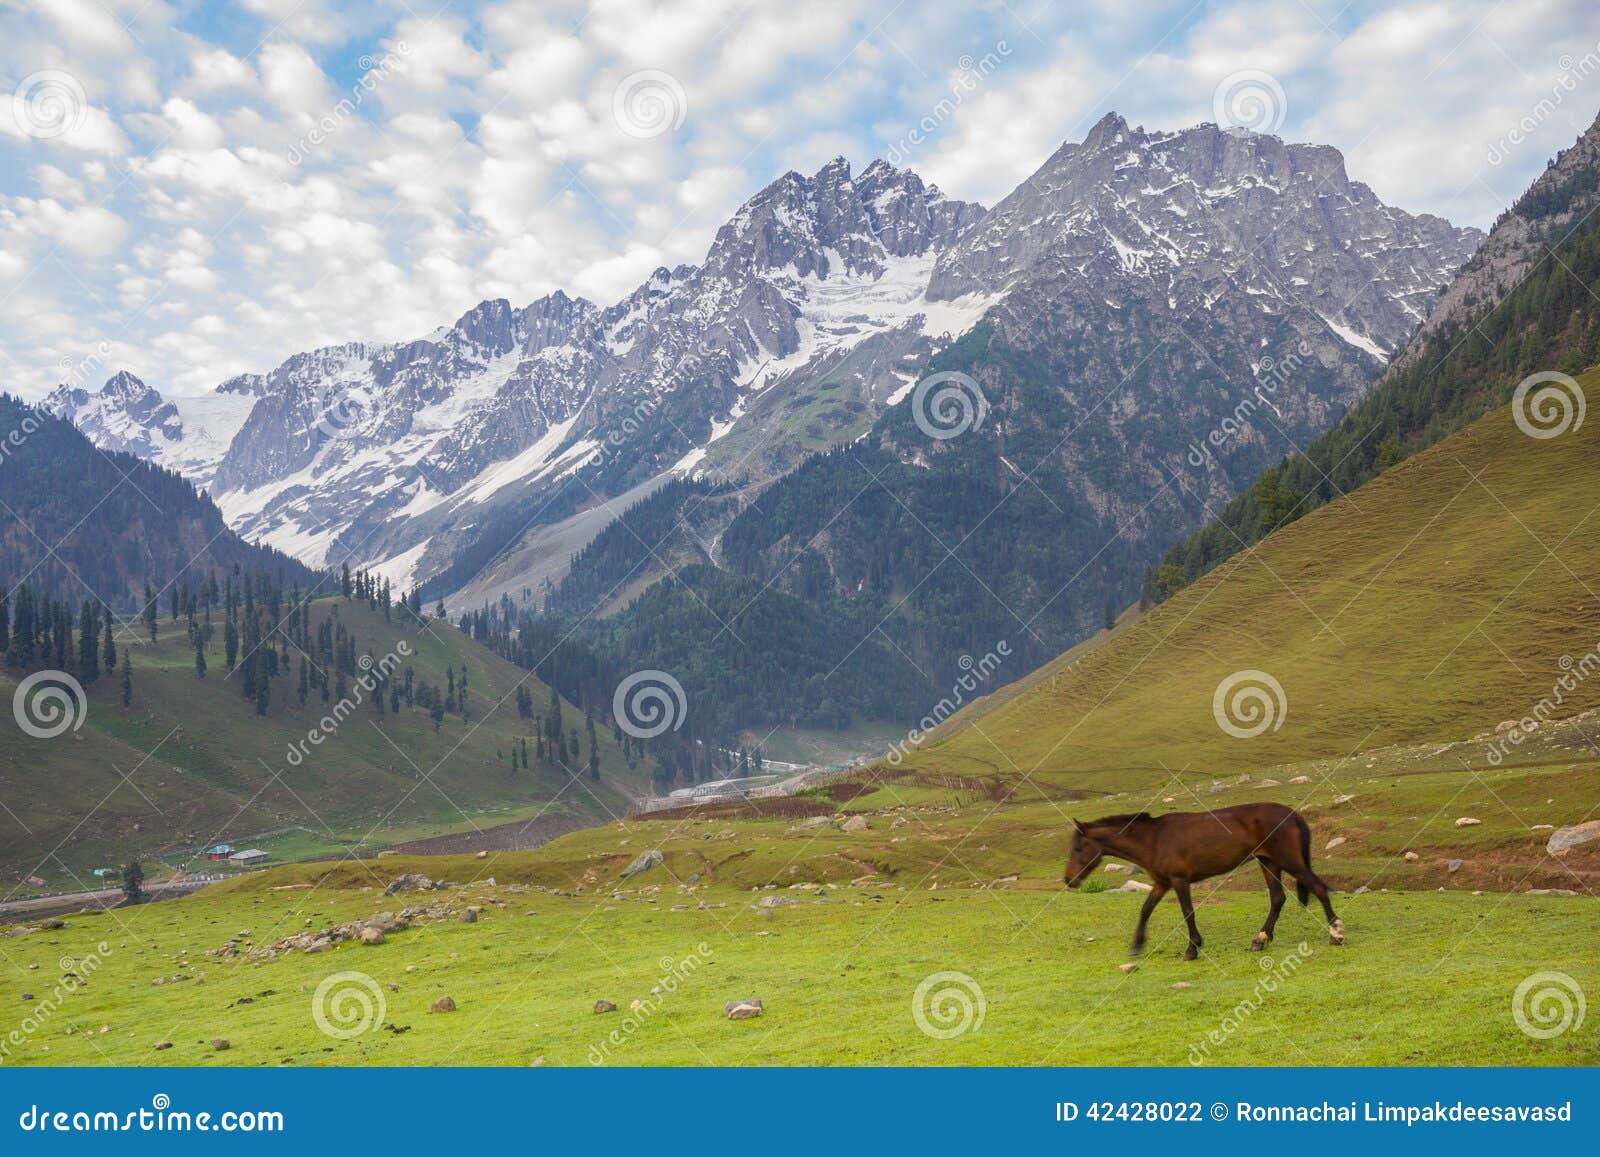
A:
[{"left": 1062, "top": 803, "right": 1344, "bottom": 960}]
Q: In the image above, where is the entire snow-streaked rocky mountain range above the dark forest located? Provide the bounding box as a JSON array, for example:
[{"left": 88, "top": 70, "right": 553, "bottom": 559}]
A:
[{"left": 53, "top": 115, "right": 1480, "bottom": 599}]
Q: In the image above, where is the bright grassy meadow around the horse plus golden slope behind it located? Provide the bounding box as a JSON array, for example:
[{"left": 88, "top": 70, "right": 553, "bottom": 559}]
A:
[{"left": 0, "top": 393, "right": 1600, "bottom": 1066}]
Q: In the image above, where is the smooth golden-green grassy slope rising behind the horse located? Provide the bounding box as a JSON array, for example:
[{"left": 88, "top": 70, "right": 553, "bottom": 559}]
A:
[{"left": 907, "top": 371, "right": 1600, "bottom": 786}]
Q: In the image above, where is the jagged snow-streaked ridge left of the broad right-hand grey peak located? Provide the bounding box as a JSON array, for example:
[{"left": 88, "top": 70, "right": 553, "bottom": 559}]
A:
[{"left": 152, "top": 150, "right": 982, "bottom": 584}]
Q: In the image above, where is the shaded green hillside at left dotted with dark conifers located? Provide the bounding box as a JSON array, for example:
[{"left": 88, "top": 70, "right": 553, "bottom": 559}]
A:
[{"left": 0, "top": 599, "right": 648, "bottom": 898}]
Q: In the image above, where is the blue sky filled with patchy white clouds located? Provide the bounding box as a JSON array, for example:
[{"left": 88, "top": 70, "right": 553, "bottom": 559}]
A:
[{"left": 0, "top": 0, "right": 1600, "bottom": 397}]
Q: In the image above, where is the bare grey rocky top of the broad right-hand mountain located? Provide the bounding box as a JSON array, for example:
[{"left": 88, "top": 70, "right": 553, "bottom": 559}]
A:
[{"left": 930, "top": 114, "right": 1483, "bottom": 360}]
